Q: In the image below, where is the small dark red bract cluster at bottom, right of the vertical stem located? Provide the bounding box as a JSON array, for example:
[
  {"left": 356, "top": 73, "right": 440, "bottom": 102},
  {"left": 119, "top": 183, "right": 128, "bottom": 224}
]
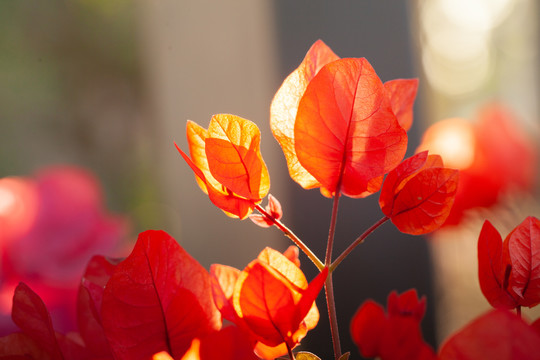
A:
[{"left": 350, "top": 289, "right": 436, "bottom": 360}]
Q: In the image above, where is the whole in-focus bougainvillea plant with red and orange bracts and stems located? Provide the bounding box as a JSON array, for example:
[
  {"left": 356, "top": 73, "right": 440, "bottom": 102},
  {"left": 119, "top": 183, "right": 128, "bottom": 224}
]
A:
[{"left": 0, "top": 41, "right": 540, "bottom": 360}]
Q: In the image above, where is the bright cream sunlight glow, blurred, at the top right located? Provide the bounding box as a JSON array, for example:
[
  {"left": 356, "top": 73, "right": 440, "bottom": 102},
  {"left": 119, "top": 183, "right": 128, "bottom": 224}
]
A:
[{"left": 419, "top": 0, "right": 516, "bottom": 96}]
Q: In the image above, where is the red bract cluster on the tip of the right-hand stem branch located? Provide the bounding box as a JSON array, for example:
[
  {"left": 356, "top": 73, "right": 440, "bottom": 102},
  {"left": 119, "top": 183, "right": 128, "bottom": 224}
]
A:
[{"left": 379, "top": 151, "right": 459, "bottom": 235}]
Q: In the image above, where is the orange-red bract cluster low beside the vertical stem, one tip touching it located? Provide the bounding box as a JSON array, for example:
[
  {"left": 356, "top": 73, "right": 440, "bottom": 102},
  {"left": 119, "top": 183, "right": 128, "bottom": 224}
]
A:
[{"left": 210, "top": 248, "right": 328, "bottom": 359}]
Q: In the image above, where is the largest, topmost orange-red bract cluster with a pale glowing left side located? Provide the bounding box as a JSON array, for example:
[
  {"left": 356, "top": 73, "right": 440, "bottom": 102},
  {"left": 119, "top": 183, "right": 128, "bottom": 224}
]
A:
[{"left": 271, "top": 41, "right": 417, "bottom": 197}]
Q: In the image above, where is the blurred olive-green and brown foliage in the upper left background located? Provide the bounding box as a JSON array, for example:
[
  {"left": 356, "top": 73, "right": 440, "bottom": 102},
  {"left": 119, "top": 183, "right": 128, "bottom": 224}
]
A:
[{"left": 0, "top": 0, "right": 157, "bottom": 233}]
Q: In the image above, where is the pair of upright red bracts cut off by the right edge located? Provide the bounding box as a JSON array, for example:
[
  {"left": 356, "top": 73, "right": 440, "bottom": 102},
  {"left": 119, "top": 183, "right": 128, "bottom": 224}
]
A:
[{"left": 478, "top": 216, "right": 540, "bottom": 309}]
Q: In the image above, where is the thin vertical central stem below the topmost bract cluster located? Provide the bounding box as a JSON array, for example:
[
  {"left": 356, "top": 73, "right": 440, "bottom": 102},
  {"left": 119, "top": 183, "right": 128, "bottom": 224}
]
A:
[{"left": 324, "top": 193, "right": 341, "bottom": 360}]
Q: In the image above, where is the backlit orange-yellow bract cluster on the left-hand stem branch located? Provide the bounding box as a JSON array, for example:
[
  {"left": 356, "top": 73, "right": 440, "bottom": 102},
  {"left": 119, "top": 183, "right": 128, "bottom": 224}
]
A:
[{"left": 176, "top": 114, "right": 270, "bottom": 219}]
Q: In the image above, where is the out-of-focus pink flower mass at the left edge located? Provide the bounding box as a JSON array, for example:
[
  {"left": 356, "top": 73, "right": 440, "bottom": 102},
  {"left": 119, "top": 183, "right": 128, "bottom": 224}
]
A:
[{"left": 0, "top": 166, "right": 129, "bottom": 334}]
